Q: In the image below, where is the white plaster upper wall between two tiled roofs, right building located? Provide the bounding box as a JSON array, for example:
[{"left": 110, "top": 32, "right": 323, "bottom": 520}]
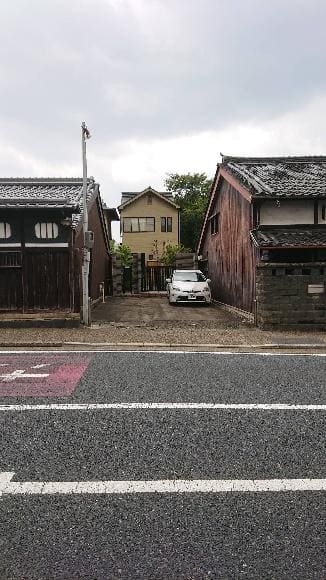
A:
[{"left": 260, "top": 199, "right": 314, "bottom": 226}]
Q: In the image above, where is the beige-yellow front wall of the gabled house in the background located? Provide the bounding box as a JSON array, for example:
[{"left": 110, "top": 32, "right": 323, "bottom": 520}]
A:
[{"left": 121, "top": 193, "right": 179, "bottom": 261}]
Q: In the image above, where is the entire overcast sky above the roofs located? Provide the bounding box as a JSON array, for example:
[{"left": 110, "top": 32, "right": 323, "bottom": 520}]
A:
[{"left": 0, "top": 0, "right": 326, "bottom": 239}]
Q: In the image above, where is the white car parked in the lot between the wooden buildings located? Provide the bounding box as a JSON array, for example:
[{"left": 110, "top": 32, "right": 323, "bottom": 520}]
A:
[{"left": 166, "top": 270, "right": 211, "bottom": 304}]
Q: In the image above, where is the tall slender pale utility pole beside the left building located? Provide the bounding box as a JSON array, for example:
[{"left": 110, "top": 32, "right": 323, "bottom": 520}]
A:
[{"left": 81, "top": 122, "right": 91, "bottom": 326}]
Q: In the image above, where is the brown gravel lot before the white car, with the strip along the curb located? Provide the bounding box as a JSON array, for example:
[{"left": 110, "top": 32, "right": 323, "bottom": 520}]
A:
[{"left": 0, "top": 296, "right": 326, "bottom": 348}]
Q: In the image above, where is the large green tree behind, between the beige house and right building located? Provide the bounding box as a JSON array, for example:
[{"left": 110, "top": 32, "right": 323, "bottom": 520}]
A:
[{"left": 165, "top": 173, "right": 212, "bottom": 252}]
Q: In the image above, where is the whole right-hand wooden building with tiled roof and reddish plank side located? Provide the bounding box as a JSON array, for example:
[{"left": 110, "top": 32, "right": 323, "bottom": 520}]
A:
[{"left": 197, "top": 156, "right": 326, "bottom": 325}]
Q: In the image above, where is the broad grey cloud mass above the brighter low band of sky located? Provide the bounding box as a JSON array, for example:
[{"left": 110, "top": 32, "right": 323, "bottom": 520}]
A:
[{"left": 1, "top": 0, "right": 326, "bottom": 146}]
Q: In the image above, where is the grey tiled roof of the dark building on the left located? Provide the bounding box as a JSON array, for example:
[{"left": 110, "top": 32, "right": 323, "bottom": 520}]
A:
[{"left": 0, "top": 177, "right": 95, "bottom": 227}]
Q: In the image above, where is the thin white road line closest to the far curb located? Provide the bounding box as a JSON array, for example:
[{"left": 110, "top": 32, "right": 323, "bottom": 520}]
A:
[{"left": 0, "top": 352, "right": 326, "bottom": 357}]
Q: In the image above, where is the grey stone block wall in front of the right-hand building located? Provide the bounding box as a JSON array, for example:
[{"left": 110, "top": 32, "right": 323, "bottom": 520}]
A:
[{"left": 256, "top": 262, "right": 326, "bottom": 329}]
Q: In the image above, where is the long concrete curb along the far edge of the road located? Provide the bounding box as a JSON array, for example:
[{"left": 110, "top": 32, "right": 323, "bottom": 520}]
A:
[{"left": 0, "top": 341, "right": 326, "bottom": 351}]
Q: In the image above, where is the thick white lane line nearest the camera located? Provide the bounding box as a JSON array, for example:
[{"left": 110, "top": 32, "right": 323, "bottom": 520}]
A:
[{"left": 0, "top": 473, "right": 326, "bottom": 495}]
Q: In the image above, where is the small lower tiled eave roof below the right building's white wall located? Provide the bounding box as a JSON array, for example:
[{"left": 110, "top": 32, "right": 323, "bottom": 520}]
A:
[{"left": 250, "top": 227, "right": 326, "bottom": 248}]
